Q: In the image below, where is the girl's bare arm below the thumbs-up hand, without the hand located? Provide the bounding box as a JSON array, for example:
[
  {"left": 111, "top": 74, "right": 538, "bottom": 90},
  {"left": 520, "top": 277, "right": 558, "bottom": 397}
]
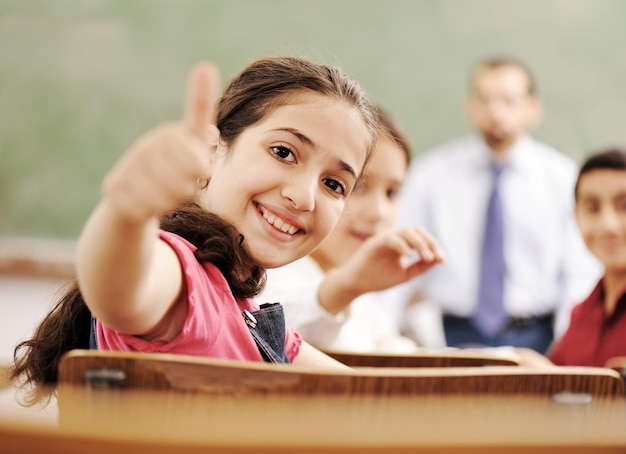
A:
[{"left": 77, "top": 198, "right": 186, "bottom": 335}]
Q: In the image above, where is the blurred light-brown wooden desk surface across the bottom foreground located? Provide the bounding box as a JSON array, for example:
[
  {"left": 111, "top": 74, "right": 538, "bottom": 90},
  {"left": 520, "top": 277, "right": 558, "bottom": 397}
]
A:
[{"left": 0, "top": 387, "right": 626, "bottom": 454}]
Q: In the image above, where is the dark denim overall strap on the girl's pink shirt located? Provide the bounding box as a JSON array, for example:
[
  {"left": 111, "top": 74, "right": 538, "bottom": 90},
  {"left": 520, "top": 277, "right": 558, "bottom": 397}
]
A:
[{"left": 242, "top": 303, "right": 290, "bottom": 363}]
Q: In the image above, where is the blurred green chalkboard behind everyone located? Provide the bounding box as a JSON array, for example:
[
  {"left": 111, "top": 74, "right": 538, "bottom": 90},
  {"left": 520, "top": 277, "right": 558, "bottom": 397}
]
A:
[{"left": 0, "top": 0, "right": 626, "bottom": 239}]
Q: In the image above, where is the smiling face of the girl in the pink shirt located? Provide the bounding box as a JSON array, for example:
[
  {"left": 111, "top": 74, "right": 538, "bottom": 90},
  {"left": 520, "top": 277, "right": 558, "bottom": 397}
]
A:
[{"left": 200, "top": 94, "right": 368, "bottom": 268}]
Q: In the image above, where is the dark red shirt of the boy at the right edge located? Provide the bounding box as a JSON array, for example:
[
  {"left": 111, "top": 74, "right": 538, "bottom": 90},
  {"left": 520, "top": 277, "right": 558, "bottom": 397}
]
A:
[{"left": 547, "top": 280, "right": 626, "bottom": 367}]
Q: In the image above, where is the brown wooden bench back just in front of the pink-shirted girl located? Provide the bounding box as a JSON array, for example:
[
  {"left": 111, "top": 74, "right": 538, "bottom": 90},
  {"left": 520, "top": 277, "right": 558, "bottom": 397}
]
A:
[{"left": 59, "top": 350, "right": 624, "bottom": 397}]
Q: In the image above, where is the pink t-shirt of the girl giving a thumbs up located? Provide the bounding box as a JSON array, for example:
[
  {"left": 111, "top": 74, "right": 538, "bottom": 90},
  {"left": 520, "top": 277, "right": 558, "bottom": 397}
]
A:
[{"left": 96, "top": 231, "right": 302, "bottom": 361}]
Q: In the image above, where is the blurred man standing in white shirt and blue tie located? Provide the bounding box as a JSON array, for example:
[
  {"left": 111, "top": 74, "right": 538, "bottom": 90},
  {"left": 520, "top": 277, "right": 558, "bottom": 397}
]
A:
[{"left": 395, "top": 59, "right": 601, "bottom": 353}]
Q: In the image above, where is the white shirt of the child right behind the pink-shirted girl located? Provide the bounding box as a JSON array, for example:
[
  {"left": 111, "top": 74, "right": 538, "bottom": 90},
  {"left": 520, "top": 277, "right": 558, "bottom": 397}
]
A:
[{"left": 255, "top": 256, "right": 418, "bottom": 353}]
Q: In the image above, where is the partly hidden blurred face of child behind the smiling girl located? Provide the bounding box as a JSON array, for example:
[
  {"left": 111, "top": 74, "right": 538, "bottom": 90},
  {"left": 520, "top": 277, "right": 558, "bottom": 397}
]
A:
[{"left": 311, "top": 139, "right": 407, "bottom": 270}]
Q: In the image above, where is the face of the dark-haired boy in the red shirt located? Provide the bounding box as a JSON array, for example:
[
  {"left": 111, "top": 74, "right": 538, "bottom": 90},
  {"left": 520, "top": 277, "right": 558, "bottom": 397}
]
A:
[{"left": 576, "top": 169, "right": 626, "bottom": 272}]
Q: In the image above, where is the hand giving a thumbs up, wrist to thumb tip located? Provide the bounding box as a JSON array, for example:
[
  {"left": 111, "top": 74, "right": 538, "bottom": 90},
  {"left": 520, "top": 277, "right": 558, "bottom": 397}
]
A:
[{"left": 102, "top": 63, "right": 220, "bottom": 221}]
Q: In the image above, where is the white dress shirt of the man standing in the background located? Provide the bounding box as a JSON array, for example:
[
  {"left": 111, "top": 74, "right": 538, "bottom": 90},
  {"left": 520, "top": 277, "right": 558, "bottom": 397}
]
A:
[{"left": 390, "top": 136, "right": 602, "bottom": 336}]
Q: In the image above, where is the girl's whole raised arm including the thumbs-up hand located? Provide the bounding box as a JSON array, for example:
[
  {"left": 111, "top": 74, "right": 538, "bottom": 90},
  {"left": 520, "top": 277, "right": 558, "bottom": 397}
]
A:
[{"left": 77, "top": 64, "right": 217, "bottom": 340}]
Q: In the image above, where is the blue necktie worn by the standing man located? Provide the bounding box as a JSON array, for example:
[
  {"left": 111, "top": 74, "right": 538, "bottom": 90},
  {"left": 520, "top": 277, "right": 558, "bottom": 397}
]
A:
[{"left": 472, "top": 165, "right": 508, "bottom": 337}]
